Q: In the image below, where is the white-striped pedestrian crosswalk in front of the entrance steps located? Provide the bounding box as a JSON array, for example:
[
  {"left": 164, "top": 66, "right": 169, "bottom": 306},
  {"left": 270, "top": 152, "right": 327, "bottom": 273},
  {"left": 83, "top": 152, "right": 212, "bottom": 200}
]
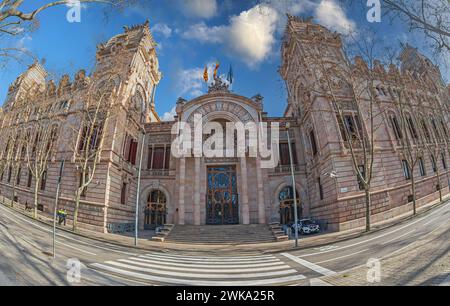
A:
[{"left": 90, "top": 252, "right": 305, "bottom": 286}]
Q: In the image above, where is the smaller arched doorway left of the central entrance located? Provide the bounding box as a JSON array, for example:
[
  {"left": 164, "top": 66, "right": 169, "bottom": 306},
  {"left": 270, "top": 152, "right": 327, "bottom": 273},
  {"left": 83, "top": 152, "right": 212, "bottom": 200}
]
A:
[{"left": 144, "top": 190, "right": 167, "bottom": 230}]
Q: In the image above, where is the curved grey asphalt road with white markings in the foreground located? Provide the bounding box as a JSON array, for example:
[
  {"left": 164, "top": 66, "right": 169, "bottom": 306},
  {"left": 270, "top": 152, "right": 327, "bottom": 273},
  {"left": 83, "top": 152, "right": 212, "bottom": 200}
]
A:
[{"left": 0, "top": 203, "right": 450, "bottom": 286}]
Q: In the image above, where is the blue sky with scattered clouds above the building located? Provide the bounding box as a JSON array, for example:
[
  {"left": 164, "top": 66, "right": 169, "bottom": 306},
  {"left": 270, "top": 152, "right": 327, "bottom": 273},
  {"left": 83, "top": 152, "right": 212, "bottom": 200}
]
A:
[{"left": 0, "top": 0, "right": 448, "bottom": 117}]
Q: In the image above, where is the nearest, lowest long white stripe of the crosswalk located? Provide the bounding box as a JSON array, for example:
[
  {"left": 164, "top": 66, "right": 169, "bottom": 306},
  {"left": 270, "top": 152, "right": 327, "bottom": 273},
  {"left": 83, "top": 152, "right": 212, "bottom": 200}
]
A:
[{"left": 92, "top": 264, "right": 305, "bottom": 286}]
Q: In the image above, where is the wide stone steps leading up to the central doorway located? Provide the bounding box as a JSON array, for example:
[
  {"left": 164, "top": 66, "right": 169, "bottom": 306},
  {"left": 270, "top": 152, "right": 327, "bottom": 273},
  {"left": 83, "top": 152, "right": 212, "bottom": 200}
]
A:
[{"left": 164, "top": 224, "right": 277, "bottom": 244}]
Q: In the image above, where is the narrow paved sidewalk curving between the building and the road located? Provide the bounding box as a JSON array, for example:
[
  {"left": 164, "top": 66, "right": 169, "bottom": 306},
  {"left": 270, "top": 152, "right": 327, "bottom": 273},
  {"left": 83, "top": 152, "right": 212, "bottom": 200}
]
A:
[{"left": 1, "top": 195, "right": 450, "bottom": 254}]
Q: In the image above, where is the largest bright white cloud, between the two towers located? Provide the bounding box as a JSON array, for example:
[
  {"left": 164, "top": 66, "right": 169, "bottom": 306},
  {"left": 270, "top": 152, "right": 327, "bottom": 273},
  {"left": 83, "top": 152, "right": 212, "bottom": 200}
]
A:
[{"left": 183, "top": 5, "right": 279, "bottom": 66}]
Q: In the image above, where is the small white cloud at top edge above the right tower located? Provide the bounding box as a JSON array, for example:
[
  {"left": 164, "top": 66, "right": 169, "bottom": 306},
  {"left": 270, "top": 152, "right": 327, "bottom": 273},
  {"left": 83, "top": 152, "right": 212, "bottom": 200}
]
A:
[{"left": 315, "top": 0, "right": 356, "bottom": 34}]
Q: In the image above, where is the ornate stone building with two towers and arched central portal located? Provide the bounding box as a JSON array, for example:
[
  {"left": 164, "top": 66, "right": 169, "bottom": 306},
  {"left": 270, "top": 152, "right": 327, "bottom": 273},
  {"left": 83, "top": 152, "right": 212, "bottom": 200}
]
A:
[{"left": 0, "top": 17, "right": 450, "bottom": 231}]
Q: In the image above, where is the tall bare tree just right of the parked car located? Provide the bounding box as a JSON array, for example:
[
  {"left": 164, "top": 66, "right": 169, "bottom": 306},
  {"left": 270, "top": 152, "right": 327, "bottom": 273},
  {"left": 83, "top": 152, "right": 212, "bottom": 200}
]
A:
[{"left": 294, "top": 29, "right": 382, "bottom": 231}]
